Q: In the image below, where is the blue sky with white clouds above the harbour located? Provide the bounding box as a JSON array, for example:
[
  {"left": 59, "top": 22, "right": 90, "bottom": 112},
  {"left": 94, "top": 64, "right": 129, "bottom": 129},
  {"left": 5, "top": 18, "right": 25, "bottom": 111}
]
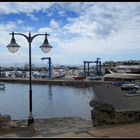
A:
[{"left": 0, "top": 2, "right": 140, "bottom": 66}]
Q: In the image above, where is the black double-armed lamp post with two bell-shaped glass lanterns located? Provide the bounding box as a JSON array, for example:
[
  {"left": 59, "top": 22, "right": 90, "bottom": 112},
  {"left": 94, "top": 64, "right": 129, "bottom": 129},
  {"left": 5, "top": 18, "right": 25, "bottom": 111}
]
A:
[{"left": 6, "top": 32, "right": 52, "bottom": 126}]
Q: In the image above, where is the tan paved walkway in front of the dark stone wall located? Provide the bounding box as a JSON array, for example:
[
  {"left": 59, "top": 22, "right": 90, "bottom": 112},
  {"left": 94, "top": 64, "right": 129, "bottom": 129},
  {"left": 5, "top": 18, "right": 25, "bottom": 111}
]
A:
[{"left": 54, "top": 123, "right": 140, "bottom": 138}]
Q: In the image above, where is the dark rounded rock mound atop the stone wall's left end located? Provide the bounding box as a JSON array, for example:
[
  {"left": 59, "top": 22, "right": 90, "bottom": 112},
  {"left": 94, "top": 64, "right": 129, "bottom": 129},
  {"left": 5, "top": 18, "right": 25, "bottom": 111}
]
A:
[{"left": 90, "top": 100, "right": 115, "bottom": 113}]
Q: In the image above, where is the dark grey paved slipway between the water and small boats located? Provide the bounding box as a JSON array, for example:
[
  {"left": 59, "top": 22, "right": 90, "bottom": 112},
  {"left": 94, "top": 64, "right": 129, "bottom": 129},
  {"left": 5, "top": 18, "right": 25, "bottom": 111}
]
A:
[{"left": 93, "top": 83, "right": 140, "bottom": 111}]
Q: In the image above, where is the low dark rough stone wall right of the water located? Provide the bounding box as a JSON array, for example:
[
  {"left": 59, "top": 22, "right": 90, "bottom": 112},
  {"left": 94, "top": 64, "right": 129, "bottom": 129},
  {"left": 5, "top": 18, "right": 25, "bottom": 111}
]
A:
[{"left": 90, "top": 100, "right": 140, "bottom": 126}]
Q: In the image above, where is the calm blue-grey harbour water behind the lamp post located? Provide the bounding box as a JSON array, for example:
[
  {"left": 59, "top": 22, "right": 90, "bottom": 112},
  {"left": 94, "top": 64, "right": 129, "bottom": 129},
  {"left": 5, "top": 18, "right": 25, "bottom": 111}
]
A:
[{"left": 0, "top": 83, "right": 94, "bottom": 120}]
